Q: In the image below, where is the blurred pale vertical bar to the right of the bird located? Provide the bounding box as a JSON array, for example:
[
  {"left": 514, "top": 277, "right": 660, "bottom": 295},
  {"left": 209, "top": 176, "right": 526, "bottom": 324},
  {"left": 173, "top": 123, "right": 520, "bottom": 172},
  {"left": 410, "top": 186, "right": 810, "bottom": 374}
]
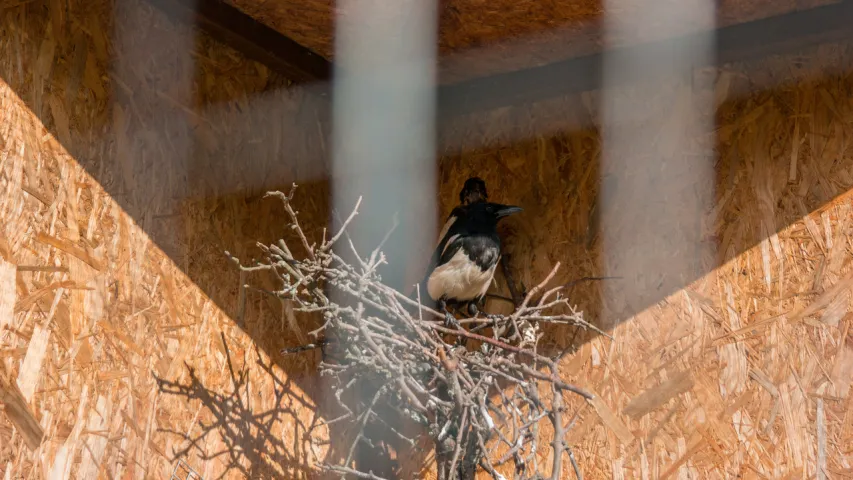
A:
[{"left": 599, "top": 0, "right": 716, "bottom": 328}]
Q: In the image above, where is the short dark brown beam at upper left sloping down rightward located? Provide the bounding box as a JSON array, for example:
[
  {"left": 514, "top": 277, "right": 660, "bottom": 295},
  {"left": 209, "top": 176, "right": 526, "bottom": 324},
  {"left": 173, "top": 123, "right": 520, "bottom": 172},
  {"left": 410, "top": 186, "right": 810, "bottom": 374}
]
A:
[{"left": 141, "top": 0, "right": 332, "bottom": 83}]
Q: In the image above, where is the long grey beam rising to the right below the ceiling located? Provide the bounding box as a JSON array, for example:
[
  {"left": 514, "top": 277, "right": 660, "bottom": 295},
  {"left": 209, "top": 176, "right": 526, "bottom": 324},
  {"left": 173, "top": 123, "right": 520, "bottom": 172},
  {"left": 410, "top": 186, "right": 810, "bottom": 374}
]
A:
[{"left": 438, "top": 0, "right": 853, "bottom": 120}]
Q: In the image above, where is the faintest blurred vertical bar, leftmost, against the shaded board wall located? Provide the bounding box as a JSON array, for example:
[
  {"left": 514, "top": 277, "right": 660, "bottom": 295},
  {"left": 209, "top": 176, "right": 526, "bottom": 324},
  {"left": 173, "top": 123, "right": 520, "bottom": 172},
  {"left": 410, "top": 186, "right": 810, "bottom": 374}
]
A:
[{"left": 111, "top": 0, "right": 196, "bottom": 259}]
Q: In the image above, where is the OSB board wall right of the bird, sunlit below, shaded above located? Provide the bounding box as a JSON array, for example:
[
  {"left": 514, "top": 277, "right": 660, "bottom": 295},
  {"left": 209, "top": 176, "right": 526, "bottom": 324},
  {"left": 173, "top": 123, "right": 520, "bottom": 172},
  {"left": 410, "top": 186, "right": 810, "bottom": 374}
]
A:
[{"left": 430, "top": 45, "right": 853, "bottom": 478}]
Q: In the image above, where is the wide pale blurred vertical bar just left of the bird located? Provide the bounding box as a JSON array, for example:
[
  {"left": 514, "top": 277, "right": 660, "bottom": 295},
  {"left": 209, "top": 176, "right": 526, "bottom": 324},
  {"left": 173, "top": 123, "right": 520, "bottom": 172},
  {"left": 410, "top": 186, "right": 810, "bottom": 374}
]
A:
[{"left": 332, "top": 0, "right": 438, "bottom": 289}]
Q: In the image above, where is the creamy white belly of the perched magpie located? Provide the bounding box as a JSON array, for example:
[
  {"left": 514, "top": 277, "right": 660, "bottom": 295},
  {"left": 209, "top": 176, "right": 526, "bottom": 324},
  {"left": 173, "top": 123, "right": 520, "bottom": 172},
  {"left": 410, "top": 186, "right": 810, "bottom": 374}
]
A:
[{"left": 427, "top": 248, "right": 497, "bottom": 301}]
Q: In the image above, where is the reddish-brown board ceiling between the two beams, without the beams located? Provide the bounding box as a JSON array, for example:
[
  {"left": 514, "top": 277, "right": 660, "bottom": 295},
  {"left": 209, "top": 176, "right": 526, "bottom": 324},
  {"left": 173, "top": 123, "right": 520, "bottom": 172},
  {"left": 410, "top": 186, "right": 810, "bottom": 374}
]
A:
[{"left": 221, "top": 0, "right": 835, "bottom": 61}]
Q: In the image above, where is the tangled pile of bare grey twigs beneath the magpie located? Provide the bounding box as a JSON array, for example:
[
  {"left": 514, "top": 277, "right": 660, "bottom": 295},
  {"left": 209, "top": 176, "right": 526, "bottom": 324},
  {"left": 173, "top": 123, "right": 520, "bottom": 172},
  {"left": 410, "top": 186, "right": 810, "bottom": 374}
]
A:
[{"left": 229, "top": 185, "right": 604, "bottom": 480}]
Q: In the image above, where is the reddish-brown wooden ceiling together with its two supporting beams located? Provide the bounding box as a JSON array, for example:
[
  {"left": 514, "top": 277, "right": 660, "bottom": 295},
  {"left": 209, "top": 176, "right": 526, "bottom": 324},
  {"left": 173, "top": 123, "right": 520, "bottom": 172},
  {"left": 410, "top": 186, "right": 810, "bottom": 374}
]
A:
[{"left": 143, "top": 0, "right": 853, "bottom": 117}]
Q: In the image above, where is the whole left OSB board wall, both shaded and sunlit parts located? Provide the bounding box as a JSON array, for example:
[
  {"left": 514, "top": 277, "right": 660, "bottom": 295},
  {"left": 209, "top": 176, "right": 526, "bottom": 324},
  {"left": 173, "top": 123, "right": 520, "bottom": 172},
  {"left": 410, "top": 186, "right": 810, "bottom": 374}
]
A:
[{"left": 0, "top": 0, "right": 326, "bottom": 479}]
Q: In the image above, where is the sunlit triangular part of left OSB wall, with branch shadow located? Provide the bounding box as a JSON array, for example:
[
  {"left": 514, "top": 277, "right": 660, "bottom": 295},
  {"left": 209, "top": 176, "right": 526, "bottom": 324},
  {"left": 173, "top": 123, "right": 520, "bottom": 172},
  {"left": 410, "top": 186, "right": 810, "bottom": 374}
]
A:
[{"left": 0, "top": 87, "right": 330, "bottom": 478}]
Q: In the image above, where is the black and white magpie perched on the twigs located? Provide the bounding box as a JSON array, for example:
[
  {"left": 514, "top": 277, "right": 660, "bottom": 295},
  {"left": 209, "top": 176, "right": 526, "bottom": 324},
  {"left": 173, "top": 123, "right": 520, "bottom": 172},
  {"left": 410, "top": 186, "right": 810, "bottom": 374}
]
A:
[{"left": 421, "top": 177, "right": 522, "bottom": 323}]
